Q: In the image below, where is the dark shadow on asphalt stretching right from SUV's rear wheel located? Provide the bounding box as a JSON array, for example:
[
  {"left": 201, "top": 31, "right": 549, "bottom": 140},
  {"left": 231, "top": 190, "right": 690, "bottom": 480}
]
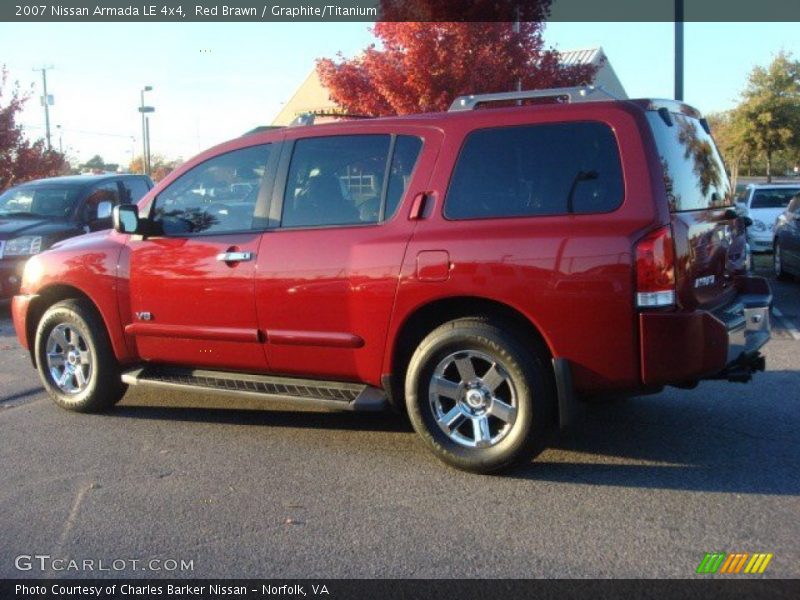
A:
[{"left": 509, "top": 371, "right": 800, "bottom": 495}]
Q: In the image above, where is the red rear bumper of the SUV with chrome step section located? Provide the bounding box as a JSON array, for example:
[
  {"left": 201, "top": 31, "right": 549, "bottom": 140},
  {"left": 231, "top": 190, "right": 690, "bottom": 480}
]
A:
[{"left": 639, "top": 277, "right": 772, "bottom": 386}]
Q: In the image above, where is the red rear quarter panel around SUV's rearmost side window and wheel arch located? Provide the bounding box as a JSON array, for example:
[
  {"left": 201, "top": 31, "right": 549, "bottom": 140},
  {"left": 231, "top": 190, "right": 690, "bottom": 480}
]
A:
[{"left": 384, "top": 103, "right": 669, "bottom": 392}]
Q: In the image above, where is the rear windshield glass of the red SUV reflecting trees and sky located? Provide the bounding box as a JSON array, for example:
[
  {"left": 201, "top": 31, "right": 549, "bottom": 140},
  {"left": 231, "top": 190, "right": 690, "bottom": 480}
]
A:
[{"left": 647, "top": 111, "right": 732, "bottom": 212}]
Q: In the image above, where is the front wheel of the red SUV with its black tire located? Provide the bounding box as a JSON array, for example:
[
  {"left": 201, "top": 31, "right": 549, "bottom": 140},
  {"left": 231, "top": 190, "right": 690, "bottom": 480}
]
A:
[{"left": 35, "top": 300, "right": 127, "bottom": 413}]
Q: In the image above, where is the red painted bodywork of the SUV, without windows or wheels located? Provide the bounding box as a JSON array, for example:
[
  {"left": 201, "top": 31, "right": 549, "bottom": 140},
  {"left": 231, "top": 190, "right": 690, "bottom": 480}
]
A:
[{"left": 7, "top": 97, "right": 768, "bottom": 393}]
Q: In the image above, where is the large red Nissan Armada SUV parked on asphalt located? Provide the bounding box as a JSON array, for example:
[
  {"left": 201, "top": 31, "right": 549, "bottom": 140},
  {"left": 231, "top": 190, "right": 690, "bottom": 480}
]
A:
[{"left": 13, "top": 88, "right": 771, "bottom": 472}]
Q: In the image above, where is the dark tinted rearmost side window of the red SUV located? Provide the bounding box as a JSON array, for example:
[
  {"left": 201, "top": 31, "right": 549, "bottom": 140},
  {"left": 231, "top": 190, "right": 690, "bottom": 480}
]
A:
[{"left": 445, "top": 122, "right": 624, "bottom": 219}]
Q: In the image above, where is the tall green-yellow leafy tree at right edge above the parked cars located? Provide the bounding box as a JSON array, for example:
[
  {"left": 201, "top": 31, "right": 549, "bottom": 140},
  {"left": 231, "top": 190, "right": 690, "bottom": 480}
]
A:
[{"left": 732, "top": 52, "right": 800, "bottom": 181}]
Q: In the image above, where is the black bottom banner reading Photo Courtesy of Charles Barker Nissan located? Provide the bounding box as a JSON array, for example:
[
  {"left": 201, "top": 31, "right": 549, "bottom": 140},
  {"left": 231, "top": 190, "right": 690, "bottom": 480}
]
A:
[{"left": 0, "top": 576, "right": 800, "bottom": 600}]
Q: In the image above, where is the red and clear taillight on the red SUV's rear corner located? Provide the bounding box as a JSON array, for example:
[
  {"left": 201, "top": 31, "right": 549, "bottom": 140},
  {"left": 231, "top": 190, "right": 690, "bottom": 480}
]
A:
[{"left": 636, "top": 225, "right": 675, "bottom": 308}]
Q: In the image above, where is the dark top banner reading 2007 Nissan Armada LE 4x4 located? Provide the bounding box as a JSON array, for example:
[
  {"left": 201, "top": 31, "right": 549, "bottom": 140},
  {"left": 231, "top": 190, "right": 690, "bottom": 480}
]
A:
[{"left": 0, "top": 0, "right": 800, "bottom": 23}]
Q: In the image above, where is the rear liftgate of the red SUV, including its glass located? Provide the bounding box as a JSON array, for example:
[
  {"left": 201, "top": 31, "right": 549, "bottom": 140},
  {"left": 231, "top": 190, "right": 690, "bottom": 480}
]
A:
[{"left": 647, "top": 108, "right": 746, "bottom": 309}]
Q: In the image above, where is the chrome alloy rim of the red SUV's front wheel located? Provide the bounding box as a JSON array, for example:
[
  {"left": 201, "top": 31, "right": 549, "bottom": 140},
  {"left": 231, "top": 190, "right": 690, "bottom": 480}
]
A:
[{"left": 47, "top": 323, "right": 93, "bottom": 395}]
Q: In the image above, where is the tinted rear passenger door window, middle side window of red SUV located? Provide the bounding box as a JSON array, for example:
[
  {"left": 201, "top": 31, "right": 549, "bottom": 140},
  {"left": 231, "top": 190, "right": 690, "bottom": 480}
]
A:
[{"left": 281, "top": 135, "right": 422, "bottom": 227}]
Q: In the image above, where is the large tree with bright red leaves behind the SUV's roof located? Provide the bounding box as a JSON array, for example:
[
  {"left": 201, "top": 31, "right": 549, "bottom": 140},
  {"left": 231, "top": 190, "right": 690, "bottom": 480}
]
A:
[{"left": 317, "top": 0, "right": 597, "bottom": 116}]
